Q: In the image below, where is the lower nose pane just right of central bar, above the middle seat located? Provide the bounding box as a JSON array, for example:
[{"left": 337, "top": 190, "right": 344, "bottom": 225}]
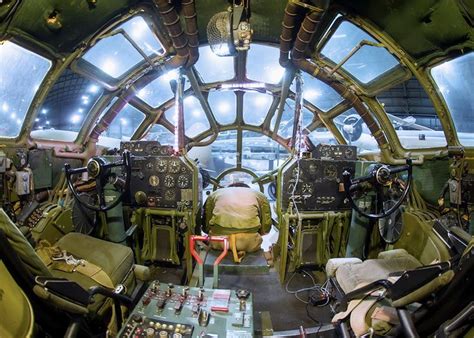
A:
[{"left": 242, "top": 131, "right": 289, "bottom": 176}]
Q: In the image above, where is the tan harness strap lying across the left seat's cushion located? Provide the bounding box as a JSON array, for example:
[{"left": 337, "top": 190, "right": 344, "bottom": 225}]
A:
[{"left": 36, "top": 240, "right": 115, "bottom": 289}]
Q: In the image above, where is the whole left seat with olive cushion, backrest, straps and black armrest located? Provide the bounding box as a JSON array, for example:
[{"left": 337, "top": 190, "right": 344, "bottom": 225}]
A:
[{"left": 0, "top": 209, "right": 149, "bottom": 331}]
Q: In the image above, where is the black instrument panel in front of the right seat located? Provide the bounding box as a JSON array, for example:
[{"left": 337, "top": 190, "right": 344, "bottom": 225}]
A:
[{"left": 281, "top": 144, "right": 357, "bottom": 211}]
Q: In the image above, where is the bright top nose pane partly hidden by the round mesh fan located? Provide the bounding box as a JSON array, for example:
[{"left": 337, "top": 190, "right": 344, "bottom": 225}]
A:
[{"left": 194, "top": 46, "right": 234, "bottom": 82}]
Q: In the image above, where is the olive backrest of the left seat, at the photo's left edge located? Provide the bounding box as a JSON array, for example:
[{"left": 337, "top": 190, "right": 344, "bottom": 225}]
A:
[{"left": 0, "top": 209, "right": 52, "bottom": 276}]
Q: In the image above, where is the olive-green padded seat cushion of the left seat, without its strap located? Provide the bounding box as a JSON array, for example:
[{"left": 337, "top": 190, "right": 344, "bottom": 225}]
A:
[{"left": 53, "top": 232, "right": 133, "bottom": 288}]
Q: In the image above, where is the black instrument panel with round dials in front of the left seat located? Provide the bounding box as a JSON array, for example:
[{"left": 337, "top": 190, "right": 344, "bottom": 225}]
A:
[{"left": 121, "top": 141, "right": 199, "bottom": 208}]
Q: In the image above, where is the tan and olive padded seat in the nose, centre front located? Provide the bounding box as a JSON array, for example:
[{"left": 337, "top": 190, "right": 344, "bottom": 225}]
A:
[{"left": 203, "top": 184, "right": 272, "bottom": 263}]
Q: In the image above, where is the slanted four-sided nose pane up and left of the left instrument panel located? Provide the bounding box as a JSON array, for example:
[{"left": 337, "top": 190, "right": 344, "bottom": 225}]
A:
[{"left": 102, "top": 104, "right": 145, "bottom": 141}]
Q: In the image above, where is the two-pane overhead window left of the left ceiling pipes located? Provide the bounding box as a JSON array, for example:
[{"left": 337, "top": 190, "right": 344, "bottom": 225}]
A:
[{"left": 82, "top": 17, "right": 163, "bottom": 79}]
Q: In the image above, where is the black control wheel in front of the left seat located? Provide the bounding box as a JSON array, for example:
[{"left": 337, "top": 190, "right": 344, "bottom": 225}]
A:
[{"left": 64, "top": 151, "right": 132, "bottom": 211}]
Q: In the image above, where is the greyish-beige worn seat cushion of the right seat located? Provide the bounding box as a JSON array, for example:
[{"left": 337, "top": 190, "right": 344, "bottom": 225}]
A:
[{"left": 336, "top": 253, "right": 422, "bottom": 293}]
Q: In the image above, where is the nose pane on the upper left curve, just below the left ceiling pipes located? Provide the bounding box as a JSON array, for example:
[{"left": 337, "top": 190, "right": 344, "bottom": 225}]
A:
[{"left": 137, "top": 70, "right": 190, "bottom": 108}]
